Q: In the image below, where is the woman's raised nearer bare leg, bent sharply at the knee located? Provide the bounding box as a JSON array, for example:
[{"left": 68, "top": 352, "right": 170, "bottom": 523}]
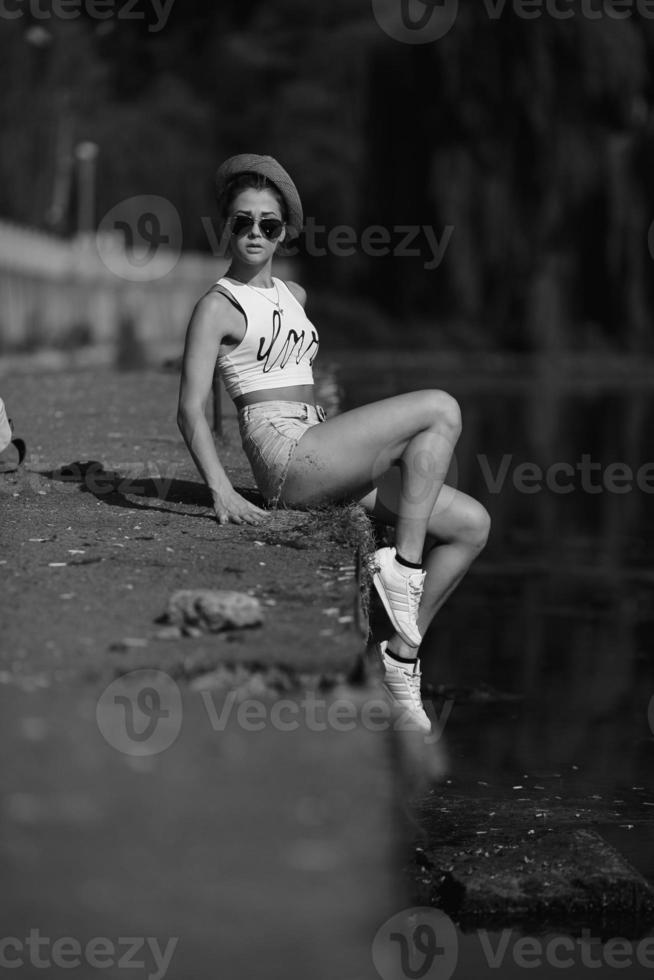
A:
[{"left": 281, "top": 390, "right": 461, "bottom": 562}]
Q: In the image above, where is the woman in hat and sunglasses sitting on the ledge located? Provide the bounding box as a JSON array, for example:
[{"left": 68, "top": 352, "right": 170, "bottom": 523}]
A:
[{"left": 178, "top": 154, "right": 490, "bottom": 732}]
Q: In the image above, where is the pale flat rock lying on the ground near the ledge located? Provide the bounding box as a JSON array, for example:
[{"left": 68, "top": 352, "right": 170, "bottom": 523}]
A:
[{"left": 164, "top": 589, "right": 263, "bottom": 635}]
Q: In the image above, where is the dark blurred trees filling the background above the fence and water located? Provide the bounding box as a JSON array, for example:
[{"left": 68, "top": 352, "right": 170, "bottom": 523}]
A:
[{"left": 0, "top": 0, "right": 654, "bottom": 350}]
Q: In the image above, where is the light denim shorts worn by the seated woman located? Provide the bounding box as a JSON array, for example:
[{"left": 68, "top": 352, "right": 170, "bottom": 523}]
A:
[{"left": 238, "top": 401, "right": 325, "bottom": 507}]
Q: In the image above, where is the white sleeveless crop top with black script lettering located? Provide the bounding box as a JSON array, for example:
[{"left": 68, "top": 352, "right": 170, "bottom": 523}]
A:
[{"left": 215, "top": 277, "right": 318, "bottom": 398}]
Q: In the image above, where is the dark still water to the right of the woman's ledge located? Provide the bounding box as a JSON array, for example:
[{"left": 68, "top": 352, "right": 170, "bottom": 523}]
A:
[{"left": 334, "top": 354, "right": 654, "bottom": 977}]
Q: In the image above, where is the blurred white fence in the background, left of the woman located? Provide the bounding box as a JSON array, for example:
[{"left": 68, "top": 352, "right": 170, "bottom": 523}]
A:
[{"left": 0, "top": 220, "right": 288, "bottom": 357}]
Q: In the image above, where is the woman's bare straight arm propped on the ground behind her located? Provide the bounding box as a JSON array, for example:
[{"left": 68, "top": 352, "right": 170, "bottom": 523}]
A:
[{"left": 177, "top": 292, "right": 267, "bottom": 524}]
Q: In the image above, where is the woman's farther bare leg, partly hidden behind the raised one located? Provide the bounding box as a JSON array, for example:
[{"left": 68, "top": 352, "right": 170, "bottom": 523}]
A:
[{"left": 361, "top": 472, "right": 490, "bottom": 658}]
